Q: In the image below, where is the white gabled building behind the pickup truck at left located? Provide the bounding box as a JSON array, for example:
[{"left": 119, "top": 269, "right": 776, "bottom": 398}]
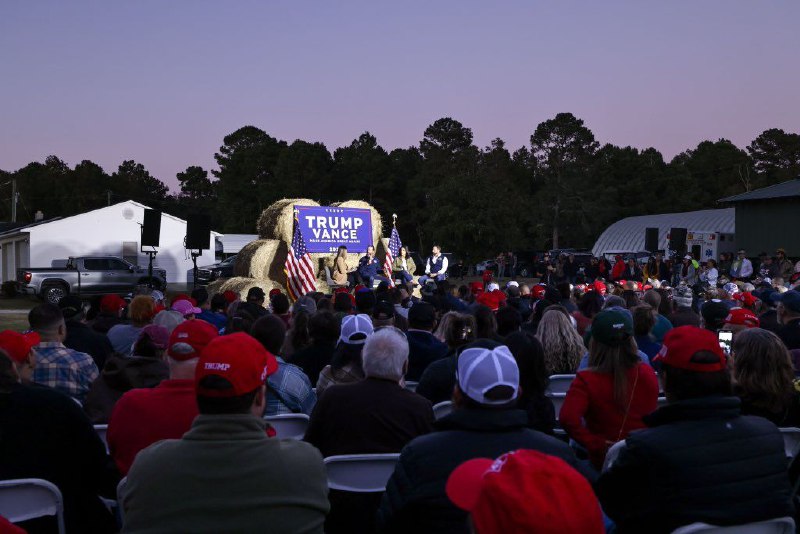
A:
[{"left": 0, "top": 200, "right": 220, "bottom": 284}]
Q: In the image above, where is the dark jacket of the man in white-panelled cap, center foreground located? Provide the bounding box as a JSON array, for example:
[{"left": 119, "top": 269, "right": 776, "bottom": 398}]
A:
[{"left": 378, "top": 408, "right": 590, "bottom": 534}]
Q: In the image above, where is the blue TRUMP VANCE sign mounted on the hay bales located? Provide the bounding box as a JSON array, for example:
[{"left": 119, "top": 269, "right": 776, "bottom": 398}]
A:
[{"left": 295, "top": 206, "right": 373, "bottom": 253}]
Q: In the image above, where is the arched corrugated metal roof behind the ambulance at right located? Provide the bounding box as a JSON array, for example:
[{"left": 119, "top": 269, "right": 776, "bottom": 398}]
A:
[{"left": 592, "top": 208, "right": 736, "bottom": 255}]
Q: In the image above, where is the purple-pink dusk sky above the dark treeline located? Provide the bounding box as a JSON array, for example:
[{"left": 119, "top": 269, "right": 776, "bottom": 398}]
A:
[{"left": 0, "top": 0, "right": 800, "bottom": 190}]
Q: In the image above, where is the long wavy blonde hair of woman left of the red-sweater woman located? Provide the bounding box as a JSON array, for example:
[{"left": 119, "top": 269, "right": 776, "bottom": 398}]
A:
[{"left": 536, "top": 310, "right": 586, "bottom": 375}]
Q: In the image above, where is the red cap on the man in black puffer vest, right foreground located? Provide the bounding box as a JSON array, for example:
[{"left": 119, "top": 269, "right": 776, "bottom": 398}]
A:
[{"left": 653, "top": 326, "right": 727, "bottom": 373}]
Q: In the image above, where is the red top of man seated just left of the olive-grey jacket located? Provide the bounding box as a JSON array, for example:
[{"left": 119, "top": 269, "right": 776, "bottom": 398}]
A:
[{"left": 106, "top": 380, "right": 197, "bottom": 476}]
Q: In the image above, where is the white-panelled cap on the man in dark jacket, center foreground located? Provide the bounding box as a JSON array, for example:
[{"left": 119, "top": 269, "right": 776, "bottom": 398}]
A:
[{"left": 456, "top": 345, "right": 519, "bottom": 405}]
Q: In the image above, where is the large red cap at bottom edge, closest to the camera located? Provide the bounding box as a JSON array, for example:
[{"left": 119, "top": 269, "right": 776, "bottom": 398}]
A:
[{"left": 445, "top": 449, "right": 605, "bottom": 534}]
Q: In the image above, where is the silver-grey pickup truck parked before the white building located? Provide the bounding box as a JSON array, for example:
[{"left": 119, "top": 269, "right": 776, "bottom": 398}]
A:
[{"left": 17, "top": 256, "right": 167, "bottom": 304}]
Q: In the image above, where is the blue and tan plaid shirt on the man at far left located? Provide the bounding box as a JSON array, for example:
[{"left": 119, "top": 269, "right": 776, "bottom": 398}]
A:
[{"left": 33, "top": 341, "right": 100, "bottom": 401}]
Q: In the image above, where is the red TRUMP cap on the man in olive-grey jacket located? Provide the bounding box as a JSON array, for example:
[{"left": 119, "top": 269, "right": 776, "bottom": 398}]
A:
[{"left": 194, "top": 332, "right": 278, "bottom": 397}]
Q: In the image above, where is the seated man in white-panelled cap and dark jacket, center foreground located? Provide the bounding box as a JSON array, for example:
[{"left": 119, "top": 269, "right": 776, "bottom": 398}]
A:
[{"left": 378, "top": 345, "right": 592, "bottom": 534}]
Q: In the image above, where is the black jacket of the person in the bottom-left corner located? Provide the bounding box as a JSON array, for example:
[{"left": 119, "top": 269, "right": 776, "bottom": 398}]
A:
[{"left": 0, "top": 385, "right": 119, "bottom": 533}]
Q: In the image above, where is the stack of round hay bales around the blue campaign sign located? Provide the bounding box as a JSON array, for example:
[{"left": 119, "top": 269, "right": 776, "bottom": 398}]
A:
[{"left": 208, "top": 198, "right": 385, "bottom": 299}]
